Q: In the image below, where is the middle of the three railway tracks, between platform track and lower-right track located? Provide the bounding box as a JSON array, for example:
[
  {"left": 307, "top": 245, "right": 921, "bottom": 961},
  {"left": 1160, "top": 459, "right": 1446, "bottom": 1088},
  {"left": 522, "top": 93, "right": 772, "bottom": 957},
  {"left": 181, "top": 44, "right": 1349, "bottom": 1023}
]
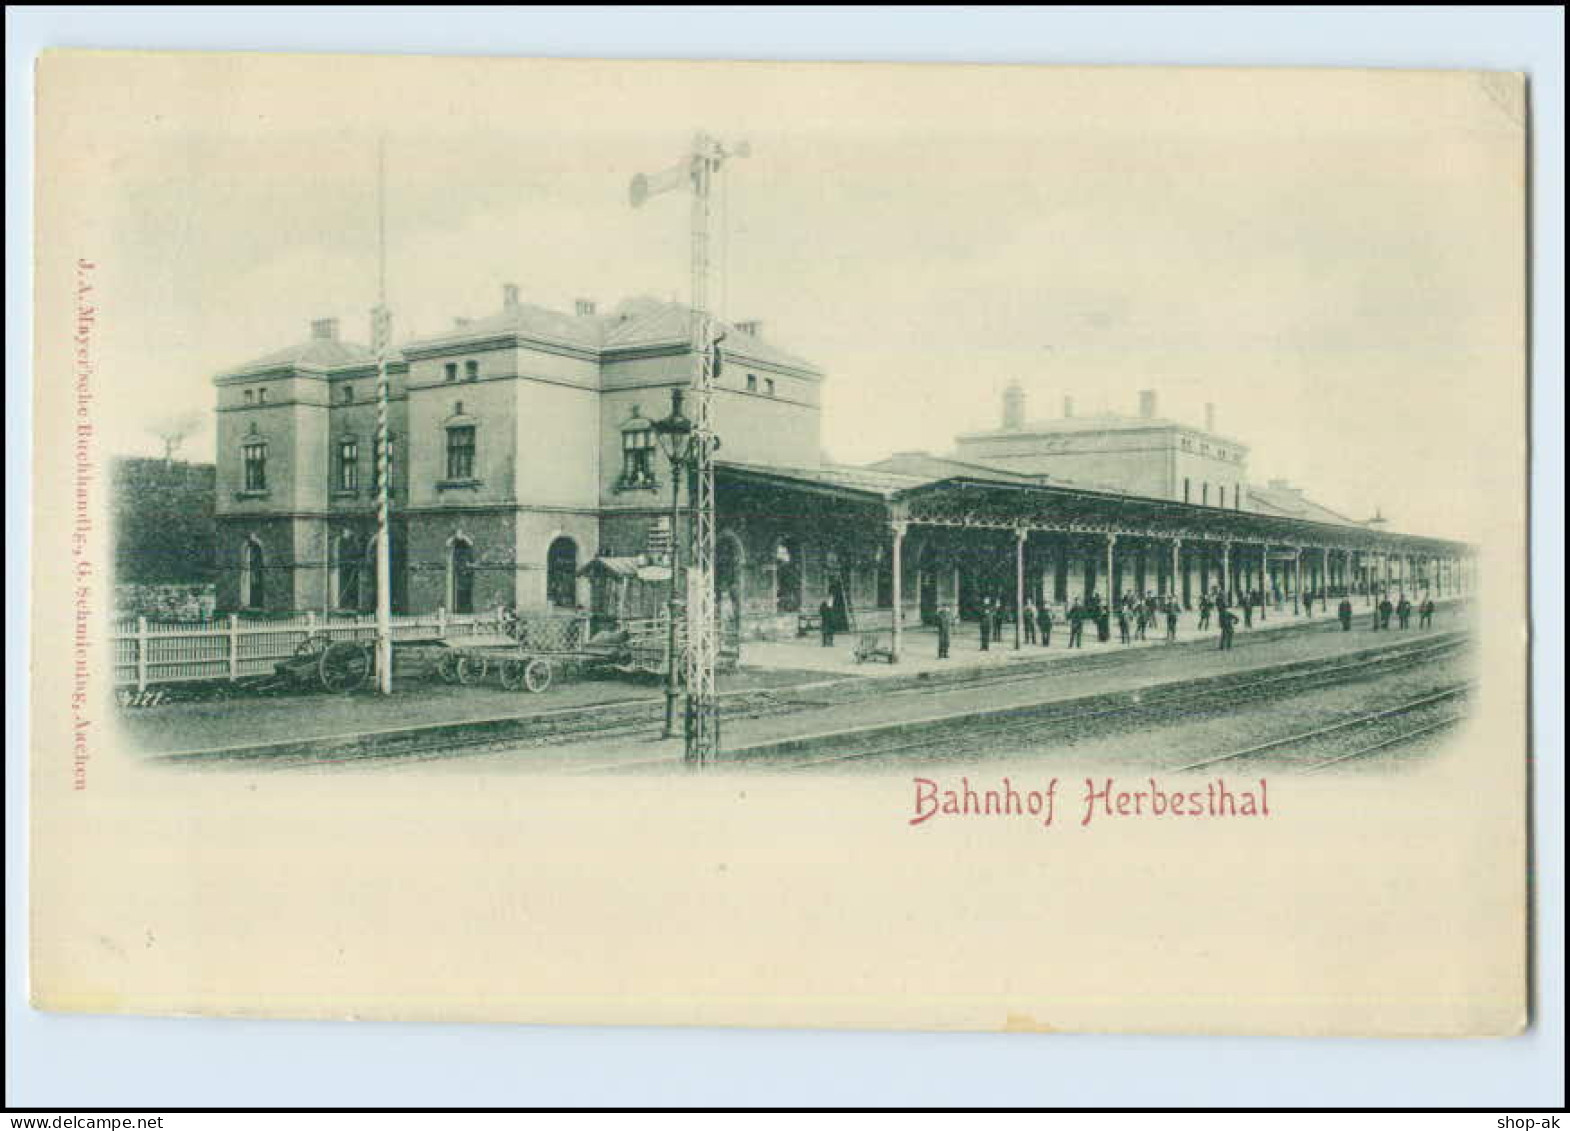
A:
[{"left": 769, "top": 638, "right": 1466, "bottom": 770}]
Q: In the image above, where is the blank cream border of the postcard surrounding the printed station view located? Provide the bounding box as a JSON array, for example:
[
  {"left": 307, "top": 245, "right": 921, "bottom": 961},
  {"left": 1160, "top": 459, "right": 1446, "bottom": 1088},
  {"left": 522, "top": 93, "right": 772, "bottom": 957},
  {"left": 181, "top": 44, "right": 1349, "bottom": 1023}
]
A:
[{"left": 31, "top": 53, "right": 1526, "bottom": 1034}]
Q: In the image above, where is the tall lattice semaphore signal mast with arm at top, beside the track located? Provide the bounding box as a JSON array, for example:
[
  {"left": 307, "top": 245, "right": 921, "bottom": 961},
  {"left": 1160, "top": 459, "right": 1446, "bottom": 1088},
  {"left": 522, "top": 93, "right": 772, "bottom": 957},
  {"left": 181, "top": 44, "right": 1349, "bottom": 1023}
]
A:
[{"left": 630, "top": 134, "right": 750, "bottom": 767}]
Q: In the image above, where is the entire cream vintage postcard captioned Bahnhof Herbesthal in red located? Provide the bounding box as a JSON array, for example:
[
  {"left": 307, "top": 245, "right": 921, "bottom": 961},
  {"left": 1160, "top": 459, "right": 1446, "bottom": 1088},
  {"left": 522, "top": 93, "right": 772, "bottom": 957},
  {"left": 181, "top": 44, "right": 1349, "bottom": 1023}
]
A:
[{"left": 31, "top": 50, "right": 1531, "bottom": 1035}]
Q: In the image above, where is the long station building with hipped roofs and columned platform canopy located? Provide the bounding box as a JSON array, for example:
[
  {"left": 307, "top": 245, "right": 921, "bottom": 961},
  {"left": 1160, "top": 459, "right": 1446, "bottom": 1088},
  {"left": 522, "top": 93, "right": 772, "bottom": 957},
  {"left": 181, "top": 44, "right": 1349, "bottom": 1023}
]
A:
[{"left": 215, "top": 284, "right": 1471, "bottom": 646}]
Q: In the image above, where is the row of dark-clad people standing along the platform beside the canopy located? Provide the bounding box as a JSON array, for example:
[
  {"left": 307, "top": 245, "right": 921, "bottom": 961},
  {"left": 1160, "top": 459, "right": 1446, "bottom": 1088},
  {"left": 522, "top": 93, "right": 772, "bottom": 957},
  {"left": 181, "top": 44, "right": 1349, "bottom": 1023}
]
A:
[{"left": 916, "top": 587, "right": 1433, "bottom": 660}]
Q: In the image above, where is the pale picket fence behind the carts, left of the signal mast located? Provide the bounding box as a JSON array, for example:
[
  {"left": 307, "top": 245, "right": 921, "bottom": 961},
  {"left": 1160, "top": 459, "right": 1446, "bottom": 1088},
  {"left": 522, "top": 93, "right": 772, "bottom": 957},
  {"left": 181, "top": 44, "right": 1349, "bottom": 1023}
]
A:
[{"left": 110, "top": 609, "right": 589, "bottom": 691}]
